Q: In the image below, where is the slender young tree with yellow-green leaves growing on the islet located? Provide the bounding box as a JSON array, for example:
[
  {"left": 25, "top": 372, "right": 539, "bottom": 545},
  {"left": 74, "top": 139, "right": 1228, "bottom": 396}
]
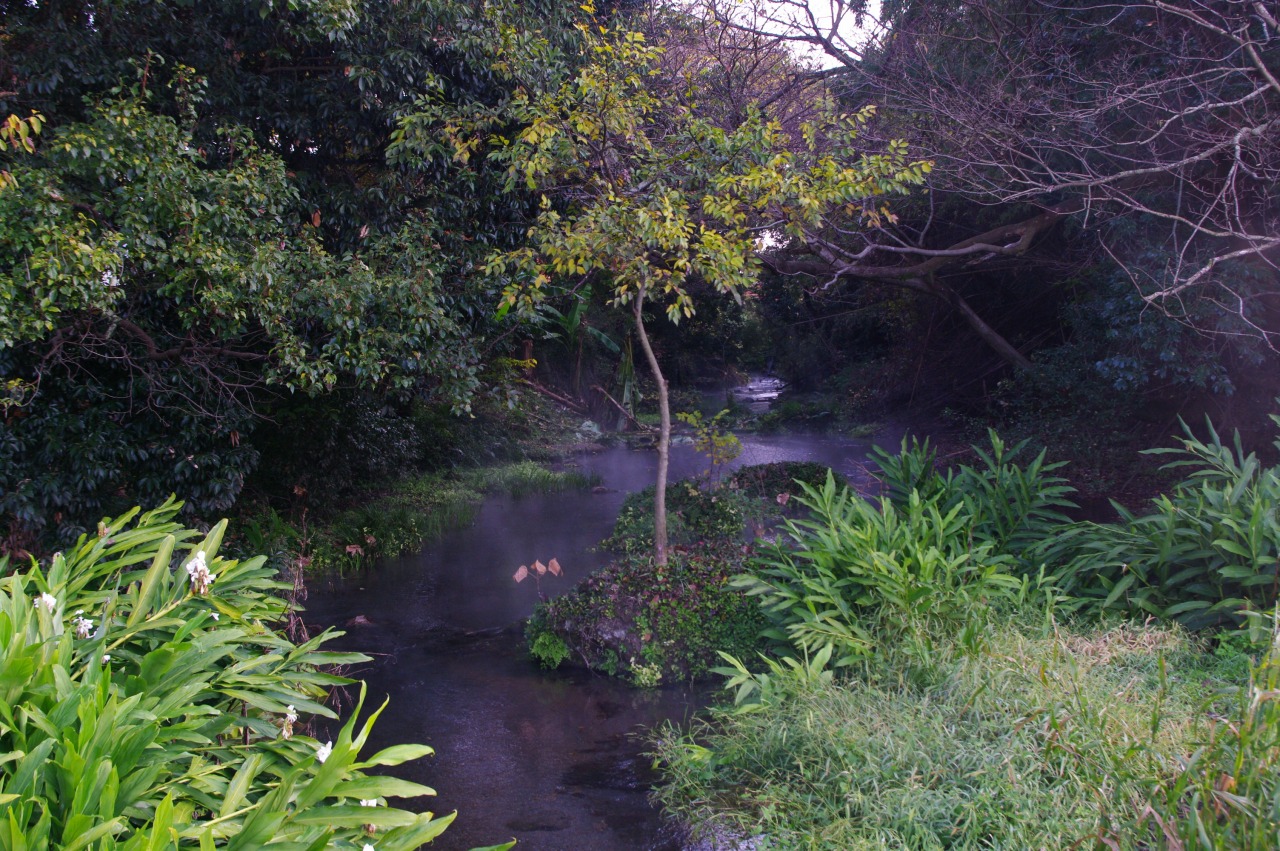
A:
[{"left": 393, "top": 8, "right": 929, "bottom": 563}]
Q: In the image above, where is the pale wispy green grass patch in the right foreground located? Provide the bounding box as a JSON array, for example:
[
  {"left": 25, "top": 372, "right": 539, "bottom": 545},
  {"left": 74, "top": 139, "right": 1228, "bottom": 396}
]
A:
[{"left": 657, "top": 616, "right": 1259, "bottom": 848}]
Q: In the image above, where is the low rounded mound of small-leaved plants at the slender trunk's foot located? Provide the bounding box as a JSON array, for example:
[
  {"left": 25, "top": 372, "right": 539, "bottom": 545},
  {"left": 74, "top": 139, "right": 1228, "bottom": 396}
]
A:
[{"left": 526, "top": 544, "right": 765, "bottom": 685}]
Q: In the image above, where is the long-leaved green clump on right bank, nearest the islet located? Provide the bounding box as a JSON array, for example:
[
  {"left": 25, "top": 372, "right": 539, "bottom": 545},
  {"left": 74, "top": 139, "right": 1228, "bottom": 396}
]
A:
[{"left": 735, "top": 434, "right": 1070, "bottom": 664}]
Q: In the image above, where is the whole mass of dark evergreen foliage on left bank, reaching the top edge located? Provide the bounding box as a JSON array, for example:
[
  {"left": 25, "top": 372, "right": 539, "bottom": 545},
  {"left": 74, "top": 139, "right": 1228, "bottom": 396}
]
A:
[{"left": 0, "top": 0, "right": 588, "bottom": 549}]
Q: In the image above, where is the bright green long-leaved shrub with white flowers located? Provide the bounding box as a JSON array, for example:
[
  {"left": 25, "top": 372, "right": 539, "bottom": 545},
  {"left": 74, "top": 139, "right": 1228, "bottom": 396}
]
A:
[{"left": 0, "top": 499, "right": 453, "bottom": 850}]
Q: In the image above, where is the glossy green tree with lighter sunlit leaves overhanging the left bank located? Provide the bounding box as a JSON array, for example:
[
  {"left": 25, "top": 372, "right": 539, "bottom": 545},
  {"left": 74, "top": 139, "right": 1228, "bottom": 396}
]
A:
[{"left": 0, "top": 92, "right": 477, "bottom": 540}]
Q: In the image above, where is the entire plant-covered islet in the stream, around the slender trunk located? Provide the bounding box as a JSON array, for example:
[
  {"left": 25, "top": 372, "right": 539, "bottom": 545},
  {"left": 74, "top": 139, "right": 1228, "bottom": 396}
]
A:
[{"left": 525, "top": 462, "right": 831, "bottom": 686}]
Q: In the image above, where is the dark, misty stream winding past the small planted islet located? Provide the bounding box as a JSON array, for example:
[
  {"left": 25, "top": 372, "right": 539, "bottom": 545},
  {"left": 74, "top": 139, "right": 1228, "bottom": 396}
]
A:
[{"left": 306, "top": 434, "right": 899, "bottom": 851}]
